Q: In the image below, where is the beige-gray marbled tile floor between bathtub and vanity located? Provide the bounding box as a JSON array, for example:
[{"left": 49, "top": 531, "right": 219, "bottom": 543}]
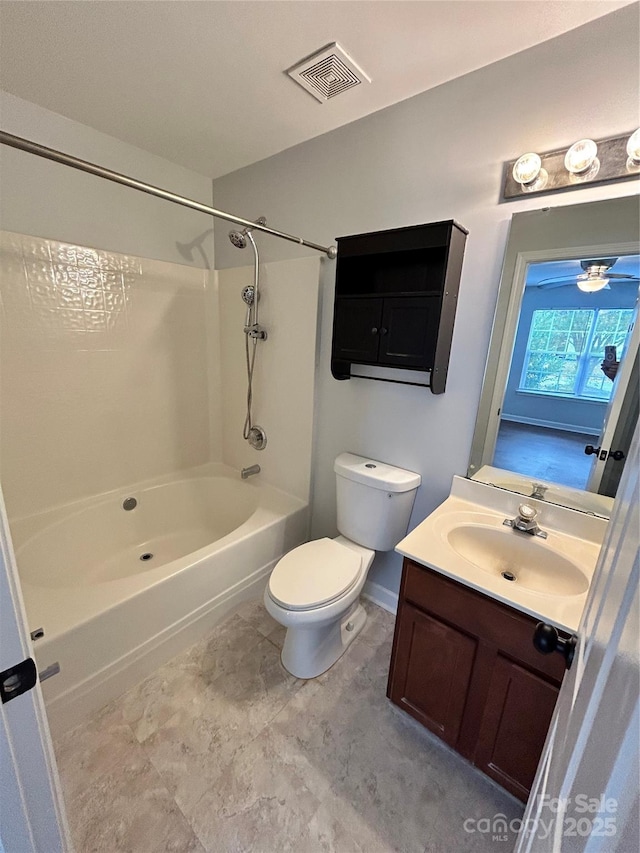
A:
[{"left": 56, "top": 602, "right": 522, "bottom": 853}]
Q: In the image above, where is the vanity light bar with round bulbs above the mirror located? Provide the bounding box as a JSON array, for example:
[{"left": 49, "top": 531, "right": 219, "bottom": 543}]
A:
[{"left": 502, "top": 129, "right": 640, "bottom": 201}]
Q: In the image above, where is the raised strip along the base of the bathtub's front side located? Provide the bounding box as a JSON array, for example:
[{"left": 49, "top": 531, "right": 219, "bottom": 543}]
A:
[{"left": 46, "top": 560, "right": 277, "bottom": 738}]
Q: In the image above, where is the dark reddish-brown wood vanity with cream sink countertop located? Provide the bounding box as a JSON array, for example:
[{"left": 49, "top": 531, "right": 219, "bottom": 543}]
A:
[{"left": 387, "top": 477, "right": 606, "bottom": 801}]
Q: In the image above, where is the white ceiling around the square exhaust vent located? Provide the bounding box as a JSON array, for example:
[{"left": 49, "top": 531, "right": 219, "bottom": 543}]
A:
[{"left": 0, "top": 0, "right": 630, "bottom": 177}]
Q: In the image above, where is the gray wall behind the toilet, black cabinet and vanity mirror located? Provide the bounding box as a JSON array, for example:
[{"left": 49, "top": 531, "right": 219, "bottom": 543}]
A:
[{"left": 214, "top": 10, "right": 640, "bottom": 604}]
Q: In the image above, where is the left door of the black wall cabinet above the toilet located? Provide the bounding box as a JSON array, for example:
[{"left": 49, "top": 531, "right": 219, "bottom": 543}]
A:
[{"left": 332, "top": 298, "right": 382, "bottom": 363}]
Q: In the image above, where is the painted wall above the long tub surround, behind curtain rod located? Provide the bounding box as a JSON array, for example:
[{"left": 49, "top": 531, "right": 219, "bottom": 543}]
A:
[{"left": 0, "top": 92, "right": 213, "bottom": 268}]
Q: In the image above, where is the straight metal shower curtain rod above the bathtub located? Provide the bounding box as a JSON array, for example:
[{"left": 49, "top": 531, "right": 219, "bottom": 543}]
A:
[{"left": 0, "top": 130, "right": 338, "bottom": 260}]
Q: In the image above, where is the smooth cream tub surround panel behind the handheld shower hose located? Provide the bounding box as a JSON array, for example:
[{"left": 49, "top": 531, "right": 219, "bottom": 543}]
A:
[{"left": 217, "top": 256, "right": 321, "bottom": 501}]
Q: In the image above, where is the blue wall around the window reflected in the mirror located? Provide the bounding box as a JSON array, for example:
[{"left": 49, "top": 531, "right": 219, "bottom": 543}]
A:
[{"left": 502, "top": 282, "right": 638, "bottom": 436}]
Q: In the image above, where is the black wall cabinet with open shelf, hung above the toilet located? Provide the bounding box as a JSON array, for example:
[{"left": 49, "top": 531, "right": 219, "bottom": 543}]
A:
[{"left": 331, "top": 220, "right": 467, "bottom": 394}]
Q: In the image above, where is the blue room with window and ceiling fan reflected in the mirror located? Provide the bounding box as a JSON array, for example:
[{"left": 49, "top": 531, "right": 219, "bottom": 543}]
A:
[{"left": 493, "top": 255, "right": 640, "bottom": 496}]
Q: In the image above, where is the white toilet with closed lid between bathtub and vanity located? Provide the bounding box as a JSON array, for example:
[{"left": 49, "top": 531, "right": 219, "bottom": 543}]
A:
[{"left": 264, "top": 453, "right": 421, "bottom": 678}]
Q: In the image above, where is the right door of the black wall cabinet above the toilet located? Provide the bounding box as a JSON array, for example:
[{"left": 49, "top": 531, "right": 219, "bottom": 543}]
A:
[{"left": 379, "top": 296, "right": 440, "bottom": 369}]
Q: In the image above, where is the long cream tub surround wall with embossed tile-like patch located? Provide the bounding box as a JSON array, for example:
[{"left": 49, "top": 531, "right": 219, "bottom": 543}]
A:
[{"left": 0, "top": 232, "right": 220, "bottom": 518}]
